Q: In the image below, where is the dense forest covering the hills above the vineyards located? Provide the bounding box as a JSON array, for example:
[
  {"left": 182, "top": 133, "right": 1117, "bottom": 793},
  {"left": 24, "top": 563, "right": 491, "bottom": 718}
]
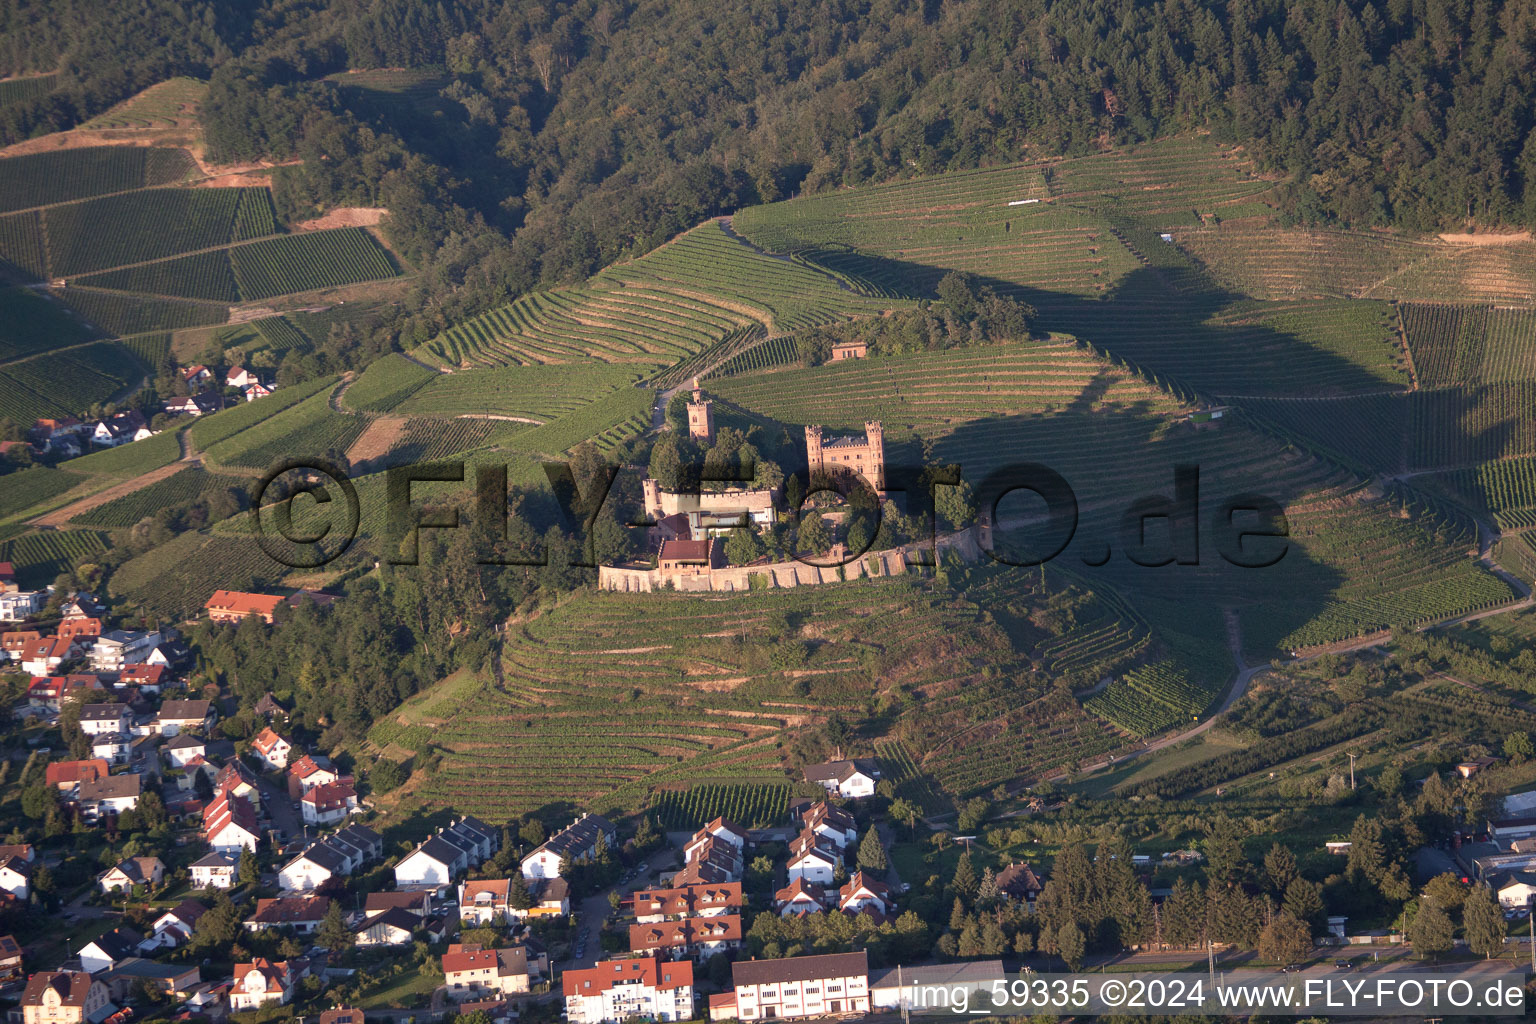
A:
[{"left": 0, "top": 0, "right": 1536, "bottom": 356}]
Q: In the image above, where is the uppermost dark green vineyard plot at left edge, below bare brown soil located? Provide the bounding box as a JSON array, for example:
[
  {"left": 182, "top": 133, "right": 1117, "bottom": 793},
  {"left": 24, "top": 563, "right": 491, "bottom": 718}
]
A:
[{"left": 0, "top": 146, "right": 197, "bottom": 213}]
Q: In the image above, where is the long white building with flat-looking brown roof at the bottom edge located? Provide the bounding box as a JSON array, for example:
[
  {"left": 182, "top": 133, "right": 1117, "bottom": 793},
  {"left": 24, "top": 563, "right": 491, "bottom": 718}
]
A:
[{"left": 731, "top": 950, "right": 869, "bottom": 1021}]
